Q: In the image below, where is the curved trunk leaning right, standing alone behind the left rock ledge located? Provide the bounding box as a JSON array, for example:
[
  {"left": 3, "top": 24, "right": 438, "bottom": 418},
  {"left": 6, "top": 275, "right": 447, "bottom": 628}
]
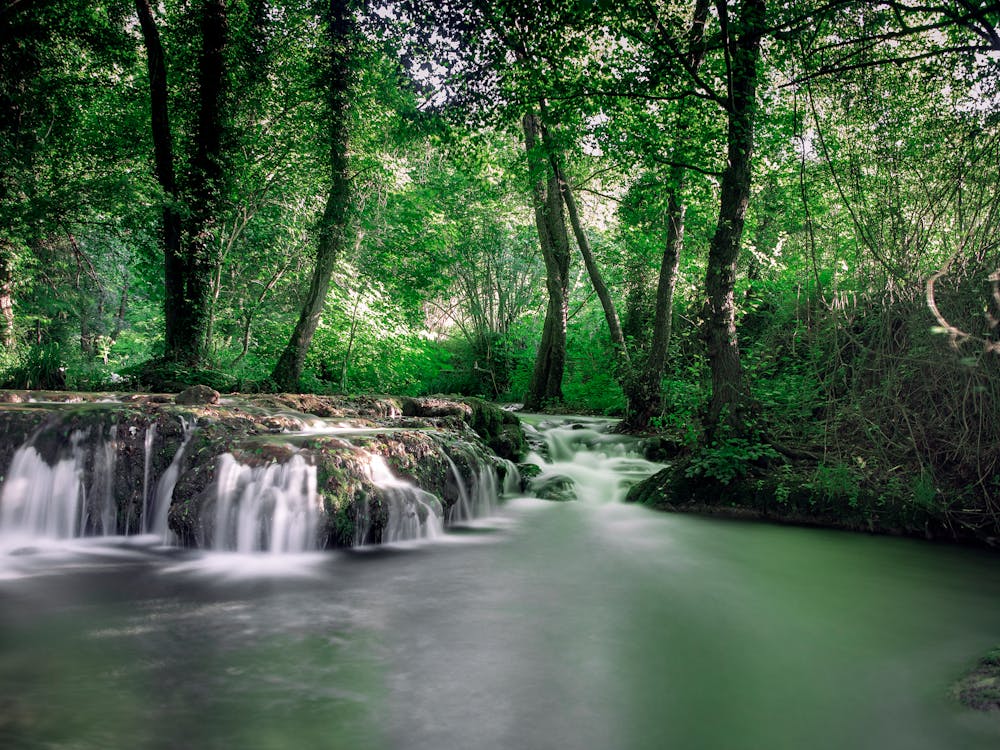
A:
[{"left": 271, "top": 0, "right": 355, "bottom": 391}]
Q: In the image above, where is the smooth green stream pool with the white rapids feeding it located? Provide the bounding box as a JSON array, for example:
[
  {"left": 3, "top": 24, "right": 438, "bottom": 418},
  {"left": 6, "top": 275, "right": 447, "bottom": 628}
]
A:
[{"left": 0, "top": 417, "right": 1000, "bottom": 750}]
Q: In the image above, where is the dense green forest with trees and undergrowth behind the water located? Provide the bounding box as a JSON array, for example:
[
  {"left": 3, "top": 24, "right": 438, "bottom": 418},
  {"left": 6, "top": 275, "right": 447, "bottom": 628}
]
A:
[{"left": 0, "top": 0, "right": 1000, "bottom": 526}]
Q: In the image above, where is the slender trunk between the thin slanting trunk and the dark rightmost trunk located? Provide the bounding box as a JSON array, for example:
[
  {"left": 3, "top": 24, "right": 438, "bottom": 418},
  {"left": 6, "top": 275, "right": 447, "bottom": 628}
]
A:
[{"left": 622, "top": 0, "right": 709, "bottom": 432}]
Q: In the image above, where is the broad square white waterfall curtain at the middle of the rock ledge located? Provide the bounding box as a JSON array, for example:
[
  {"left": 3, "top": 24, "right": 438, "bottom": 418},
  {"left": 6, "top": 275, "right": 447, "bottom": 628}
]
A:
[{"left": 210, "top": 453, "right": 320, "bottom": 554}]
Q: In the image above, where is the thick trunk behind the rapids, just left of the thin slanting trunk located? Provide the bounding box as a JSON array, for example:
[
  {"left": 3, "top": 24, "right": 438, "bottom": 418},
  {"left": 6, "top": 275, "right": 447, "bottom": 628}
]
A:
[{"left": 521, "top": 114, "right": 569, "bottom": 409}]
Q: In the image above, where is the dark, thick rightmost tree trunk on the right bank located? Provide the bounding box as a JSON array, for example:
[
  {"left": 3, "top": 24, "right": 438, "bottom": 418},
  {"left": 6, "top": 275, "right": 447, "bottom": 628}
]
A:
[{"left": 704, "top": 0, "right": 765, "bottom": 437}]
